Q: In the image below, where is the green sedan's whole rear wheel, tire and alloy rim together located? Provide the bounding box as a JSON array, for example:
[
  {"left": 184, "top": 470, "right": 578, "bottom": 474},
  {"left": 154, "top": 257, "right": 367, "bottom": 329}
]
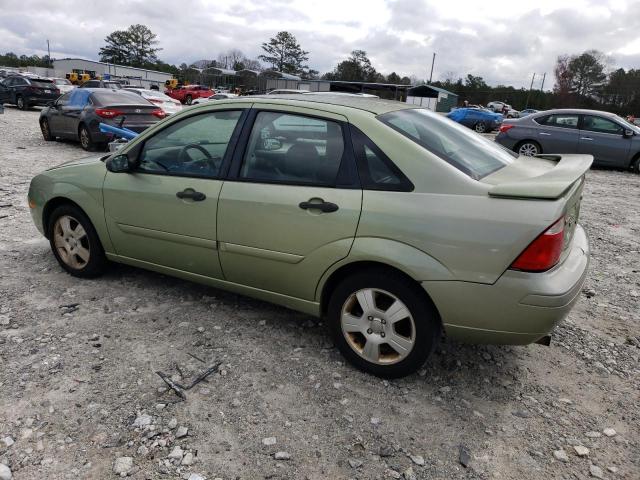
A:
[{"left": 327, "top": 269, "right": 440, "bottom": 378}]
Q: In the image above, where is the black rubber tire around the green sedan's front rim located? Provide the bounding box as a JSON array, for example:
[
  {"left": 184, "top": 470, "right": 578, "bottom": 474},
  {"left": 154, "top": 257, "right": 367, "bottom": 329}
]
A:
[{"left": 47, "top": 204, "right": 108, "bottom": 278}]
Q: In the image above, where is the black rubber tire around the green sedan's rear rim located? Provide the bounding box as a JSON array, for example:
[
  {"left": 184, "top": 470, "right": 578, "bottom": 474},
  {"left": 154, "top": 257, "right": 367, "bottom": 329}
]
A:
[{"left": 327, "top": 268, "right": 441, "bottom": 378}]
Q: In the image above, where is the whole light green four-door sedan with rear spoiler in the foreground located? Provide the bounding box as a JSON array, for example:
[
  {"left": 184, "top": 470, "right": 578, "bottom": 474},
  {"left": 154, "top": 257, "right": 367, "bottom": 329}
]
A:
[{"left": 28, "top": 95, "right": 593, "bottom": 377}]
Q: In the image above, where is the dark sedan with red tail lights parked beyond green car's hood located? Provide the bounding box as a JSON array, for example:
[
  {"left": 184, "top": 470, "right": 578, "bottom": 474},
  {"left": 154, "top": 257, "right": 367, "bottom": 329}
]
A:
[{"left": 40, "top": 88, "right": 166, "bottom": 151}]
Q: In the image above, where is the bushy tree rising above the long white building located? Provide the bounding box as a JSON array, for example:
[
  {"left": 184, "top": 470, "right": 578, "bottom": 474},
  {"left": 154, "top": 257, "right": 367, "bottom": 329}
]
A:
[{"left": 99, "top": 24, "right": 162, "bottom": 67}]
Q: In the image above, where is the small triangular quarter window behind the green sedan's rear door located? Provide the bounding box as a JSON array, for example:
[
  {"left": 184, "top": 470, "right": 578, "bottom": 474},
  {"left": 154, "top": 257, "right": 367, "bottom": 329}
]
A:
[{"left": 351, "top": 126, "right": 413, "bottom": 192}]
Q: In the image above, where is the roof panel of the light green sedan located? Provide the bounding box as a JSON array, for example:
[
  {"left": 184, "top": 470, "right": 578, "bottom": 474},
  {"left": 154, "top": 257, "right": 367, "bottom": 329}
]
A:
[{"left": 235, "top": 94, "right": 419, "bottom": 115}]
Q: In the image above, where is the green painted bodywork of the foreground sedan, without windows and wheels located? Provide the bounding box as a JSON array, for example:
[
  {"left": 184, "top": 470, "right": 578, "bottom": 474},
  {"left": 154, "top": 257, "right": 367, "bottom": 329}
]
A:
[{"left": 29, "top": 95, "right": 592, "bottom": 344}]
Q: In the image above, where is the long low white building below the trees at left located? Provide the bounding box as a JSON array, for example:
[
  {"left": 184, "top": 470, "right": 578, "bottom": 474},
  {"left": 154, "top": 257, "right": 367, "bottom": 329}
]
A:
[{"left": 49, "top": 58, "right": 172, "bottom": 88}]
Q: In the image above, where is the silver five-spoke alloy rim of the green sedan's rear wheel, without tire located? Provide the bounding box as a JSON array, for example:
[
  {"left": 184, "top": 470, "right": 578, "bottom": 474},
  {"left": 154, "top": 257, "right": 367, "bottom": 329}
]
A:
[{"left": 340, "top": 288, "right": 416, "bottom": 365}]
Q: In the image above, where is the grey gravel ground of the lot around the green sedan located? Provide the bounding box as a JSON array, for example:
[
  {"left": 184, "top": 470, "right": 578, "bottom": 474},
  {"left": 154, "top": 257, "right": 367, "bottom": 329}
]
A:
[{"left": 0, "top": 108, "right": 640, "bottom": 480}]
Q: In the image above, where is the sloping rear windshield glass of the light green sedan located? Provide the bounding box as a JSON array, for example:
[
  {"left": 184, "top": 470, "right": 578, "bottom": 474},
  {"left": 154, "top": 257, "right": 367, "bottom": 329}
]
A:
[{"left": 378, "top": 108, "right": 516, "bottom": 180}]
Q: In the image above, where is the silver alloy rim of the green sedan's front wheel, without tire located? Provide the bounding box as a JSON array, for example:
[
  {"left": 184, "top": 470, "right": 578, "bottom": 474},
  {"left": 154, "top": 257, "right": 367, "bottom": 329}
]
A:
[{"left": 53, "top": 215, "right": 91, "bottom": 270}]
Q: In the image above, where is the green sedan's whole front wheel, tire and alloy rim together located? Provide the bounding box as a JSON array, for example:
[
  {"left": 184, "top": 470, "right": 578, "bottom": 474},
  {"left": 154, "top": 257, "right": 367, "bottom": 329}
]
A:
[{"left": 47, "top": 204, "right": 107, "bottom": 278}]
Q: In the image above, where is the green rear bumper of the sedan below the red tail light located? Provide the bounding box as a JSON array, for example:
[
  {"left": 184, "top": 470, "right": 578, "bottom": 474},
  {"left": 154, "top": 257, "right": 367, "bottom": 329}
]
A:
[{"left": 422, "top": 225, "right": 589, "bottom": 345}]
